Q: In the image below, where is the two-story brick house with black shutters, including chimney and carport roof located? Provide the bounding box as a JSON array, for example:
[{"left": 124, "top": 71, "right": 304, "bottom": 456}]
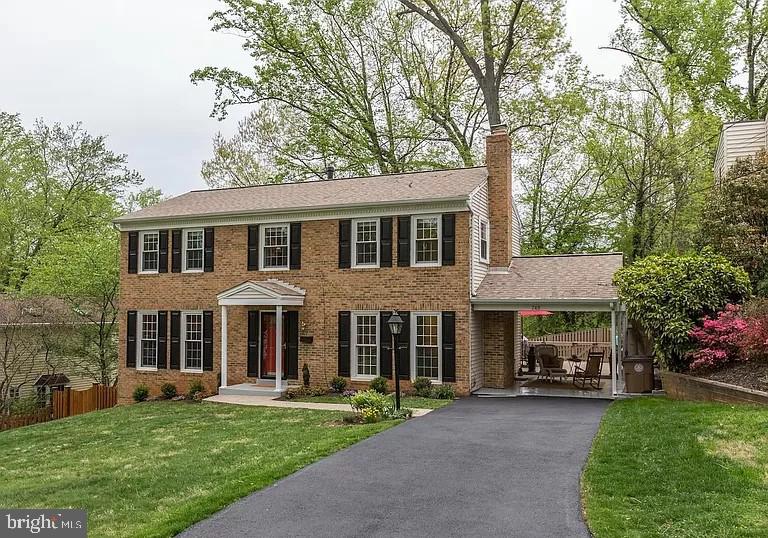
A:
[{"left": 116, "top": 126, "right": 622, "bottom": 402}]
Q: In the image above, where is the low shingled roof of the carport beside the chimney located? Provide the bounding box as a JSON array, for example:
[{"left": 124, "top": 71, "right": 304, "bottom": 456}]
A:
[{"left": 472, "top": 252, "right": 624, "bottom": 311}]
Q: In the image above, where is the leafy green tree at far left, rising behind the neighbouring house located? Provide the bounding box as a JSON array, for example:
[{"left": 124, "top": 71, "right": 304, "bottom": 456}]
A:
[{"left": 0, "top": 113, "right": 142, "bottom": 290}]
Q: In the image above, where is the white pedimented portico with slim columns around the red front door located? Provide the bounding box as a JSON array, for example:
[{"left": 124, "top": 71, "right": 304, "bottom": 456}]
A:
[{"left": 216, "top": 279, "right": 306, "bottom": 393}]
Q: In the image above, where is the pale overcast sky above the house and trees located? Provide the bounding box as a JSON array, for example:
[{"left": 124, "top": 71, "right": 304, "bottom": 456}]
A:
[{"left": 0, "top": 0, "right": 621, "bottom": 194}]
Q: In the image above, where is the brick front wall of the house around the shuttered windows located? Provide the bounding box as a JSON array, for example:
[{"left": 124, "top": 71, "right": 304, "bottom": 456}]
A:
[{"left": 119, "top": 211, "right": 470, "bottom": 402}]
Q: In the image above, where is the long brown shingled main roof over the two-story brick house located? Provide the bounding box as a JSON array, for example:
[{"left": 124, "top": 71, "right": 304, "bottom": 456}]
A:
[{"left": 115, "top": 166, "right": 488, "bottom": 224}]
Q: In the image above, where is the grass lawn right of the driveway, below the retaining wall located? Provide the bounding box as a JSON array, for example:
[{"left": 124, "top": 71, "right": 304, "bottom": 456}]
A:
[{"left": 582, "top": 398, "right": 768, "bottom": 538}]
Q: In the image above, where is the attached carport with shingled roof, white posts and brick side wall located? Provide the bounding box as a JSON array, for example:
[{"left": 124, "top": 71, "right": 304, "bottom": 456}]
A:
[{"left": 471, "top": 253, "right": 626, "bottom": 396}]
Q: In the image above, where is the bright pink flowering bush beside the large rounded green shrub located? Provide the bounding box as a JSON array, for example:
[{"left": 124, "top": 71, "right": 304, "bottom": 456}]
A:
[{"left": 688, "top": 304, "right": 750, "bottom": 370}]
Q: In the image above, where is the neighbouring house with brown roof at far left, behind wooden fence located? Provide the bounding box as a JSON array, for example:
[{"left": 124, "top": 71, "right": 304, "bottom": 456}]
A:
[{"left": 0, "top": 296, "right": 92, "bottom": 403}]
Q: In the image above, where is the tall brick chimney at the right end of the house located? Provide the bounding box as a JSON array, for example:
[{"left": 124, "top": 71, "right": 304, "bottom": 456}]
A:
[{"left": 485, "top": 124, "right": 514, "bottom": 267}]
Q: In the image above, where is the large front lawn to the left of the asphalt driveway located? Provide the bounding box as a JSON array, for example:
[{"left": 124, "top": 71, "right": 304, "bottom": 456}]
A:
[{"left": 0, "top": 402, "right": 397, "bottom": 537}]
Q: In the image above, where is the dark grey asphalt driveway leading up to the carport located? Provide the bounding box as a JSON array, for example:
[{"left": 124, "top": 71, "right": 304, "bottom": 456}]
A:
[{"left": 182, "top": 398, "right": 608, "bottom": 538}]
